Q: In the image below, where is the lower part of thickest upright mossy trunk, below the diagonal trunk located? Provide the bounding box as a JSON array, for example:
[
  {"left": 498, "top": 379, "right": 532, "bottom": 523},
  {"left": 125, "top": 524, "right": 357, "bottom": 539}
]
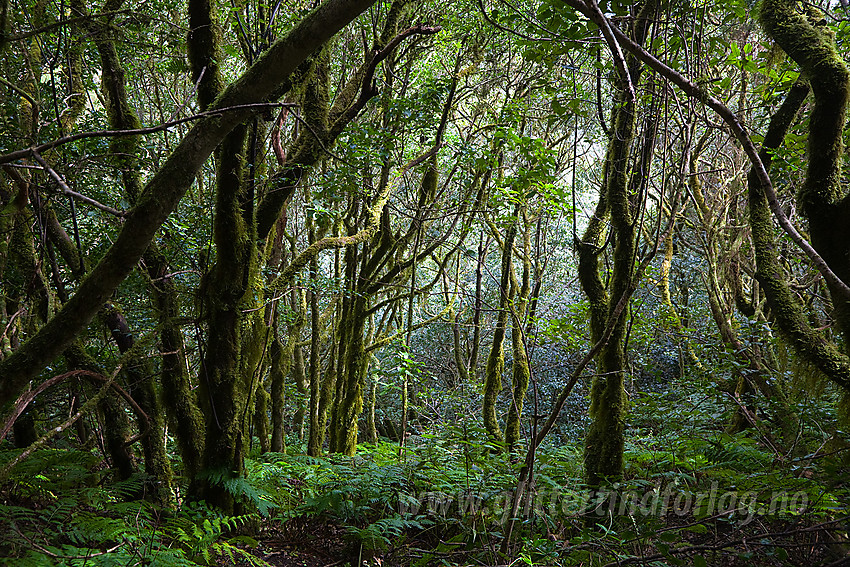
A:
[{"left": 193, "top": 82, "right": 255, "bottom": 513}]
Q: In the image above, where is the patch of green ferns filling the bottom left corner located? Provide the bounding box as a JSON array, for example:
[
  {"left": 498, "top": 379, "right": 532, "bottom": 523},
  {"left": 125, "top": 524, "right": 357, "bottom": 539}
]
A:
[{"left": 0, "top": 449, "right": 267, "bottom": 567}]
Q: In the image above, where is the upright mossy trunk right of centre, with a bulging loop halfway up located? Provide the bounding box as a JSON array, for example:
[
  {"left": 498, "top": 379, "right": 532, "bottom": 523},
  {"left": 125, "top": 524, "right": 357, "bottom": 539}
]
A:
[{"left": 577, "top": 0, "right": 655, "bottom": 487}]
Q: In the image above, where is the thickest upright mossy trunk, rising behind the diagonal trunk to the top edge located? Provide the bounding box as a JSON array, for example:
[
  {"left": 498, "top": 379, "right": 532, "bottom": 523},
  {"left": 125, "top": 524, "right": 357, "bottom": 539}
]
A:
[{"left": 188, "top": 0, "right": 257, "bottom": 513}]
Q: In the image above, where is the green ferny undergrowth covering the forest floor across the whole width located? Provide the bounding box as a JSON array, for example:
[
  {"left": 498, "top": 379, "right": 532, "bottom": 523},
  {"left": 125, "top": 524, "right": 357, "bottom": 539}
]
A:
[{"left": 0, "top": 374, "right": 848, "bottom": 566}]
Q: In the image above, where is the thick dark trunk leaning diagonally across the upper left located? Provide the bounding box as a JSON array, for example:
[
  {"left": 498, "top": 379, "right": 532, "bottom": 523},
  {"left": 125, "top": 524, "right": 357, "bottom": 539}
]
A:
[{"left": 0, "top": 0, "right": 373, "bottom": 409}]
